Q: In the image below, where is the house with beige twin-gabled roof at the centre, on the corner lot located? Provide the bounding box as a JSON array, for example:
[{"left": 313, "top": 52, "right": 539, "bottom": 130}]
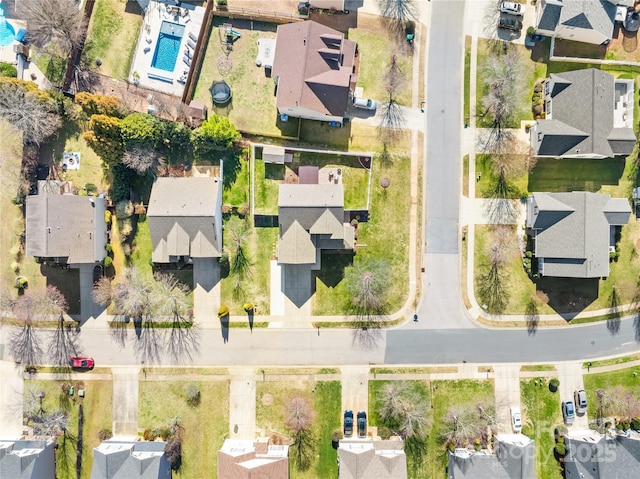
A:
[{"left": 278, "top": 184, "right": 355, "bottom": 270}]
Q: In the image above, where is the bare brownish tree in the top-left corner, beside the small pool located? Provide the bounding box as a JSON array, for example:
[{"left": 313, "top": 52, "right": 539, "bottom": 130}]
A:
[{"left": 17, "top": 0, "right": 86, "bottom": 55}]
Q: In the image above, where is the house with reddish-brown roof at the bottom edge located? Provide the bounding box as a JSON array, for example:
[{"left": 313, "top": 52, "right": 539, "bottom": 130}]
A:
[{"left": 218, "top": 438, "right": 289, "bottom": 479}]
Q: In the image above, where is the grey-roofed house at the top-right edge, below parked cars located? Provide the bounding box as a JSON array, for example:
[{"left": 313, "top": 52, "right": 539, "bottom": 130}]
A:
[{"left": 534, "top": 0, "right": 633, "bottom": 45}]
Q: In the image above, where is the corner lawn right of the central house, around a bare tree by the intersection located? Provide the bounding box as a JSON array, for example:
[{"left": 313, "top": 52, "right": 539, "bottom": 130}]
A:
[{"left": 312, "top": 156, "right": 411, "bottom": 315}]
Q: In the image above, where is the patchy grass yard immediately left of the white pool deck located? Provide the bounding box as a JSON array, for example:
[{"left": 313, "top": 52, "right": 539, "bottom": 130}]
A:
[{"left": 83, "top": 0, "right": 143, "bottom": 80}]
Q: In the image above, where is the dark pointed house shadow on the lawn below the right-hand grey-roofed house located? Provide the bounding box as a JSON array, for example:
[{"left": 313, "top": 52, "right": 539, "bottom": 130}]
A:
[{"left": 536, "top": 277, "right": 599, "bottom": 321}]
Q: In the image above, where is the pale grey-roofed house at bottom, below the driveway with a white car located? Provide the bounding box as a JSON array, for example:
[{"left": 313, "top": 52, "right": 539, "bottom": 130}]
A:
[{"left": 447, "top": 434, "right": 536, "bottom": 479}]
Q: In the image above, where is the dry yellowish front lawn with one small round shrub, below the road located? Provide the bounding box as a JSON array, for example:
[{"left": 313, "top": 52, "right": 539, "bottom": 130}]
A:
[{"left": 138, "top": 381, "right": 229, "bottom": 479}]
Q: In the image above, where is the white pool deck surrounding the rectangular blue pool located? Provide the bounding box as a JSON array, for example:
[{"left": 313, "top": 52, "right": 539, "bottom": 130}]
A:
[{"left": 129, "top": 1, "right": 205, "bottom": 96}]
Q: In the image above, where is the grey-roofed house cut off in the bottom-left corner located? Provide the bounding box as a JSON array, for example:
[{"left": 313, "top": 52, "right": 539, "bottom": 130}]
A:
[{"left": 0, "top": 438, "right": 56, "bottom": 479}]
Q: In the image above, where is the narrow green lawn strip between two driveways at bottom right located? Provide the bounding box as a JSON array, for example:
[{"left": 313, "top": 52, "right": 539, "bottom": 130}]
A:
[{"left": 520, "top": 378, "right": 562, "bottom": 479}]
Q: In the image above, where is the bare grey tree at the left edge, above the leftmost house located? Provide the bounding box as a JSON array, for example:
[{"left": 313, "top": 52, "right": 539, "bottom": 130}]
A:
[{"left": 0, "top": 80, "right": 60, "bottom": 145}]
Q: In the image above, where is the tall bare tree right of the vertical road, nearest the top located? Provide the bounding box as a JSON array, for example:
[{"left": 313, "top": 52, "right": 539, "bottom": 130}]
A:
[{"left": 480, "top": 48, "right": 524, "bottom": 152}]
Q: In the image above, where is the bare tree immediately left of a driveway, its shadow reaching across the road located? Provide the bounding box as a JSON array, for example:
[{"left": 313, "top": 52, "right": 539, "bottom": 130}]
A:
[{"left": 153, "top": 273, "right": 200, "bottom": 362}]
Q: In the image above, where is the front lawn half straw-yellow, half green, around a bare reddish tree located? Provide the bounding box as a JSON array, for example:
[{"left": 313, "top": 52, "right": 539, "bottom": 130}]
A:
[{"left": 256, "top": 381, "right": 342, "bottom": 479}]
